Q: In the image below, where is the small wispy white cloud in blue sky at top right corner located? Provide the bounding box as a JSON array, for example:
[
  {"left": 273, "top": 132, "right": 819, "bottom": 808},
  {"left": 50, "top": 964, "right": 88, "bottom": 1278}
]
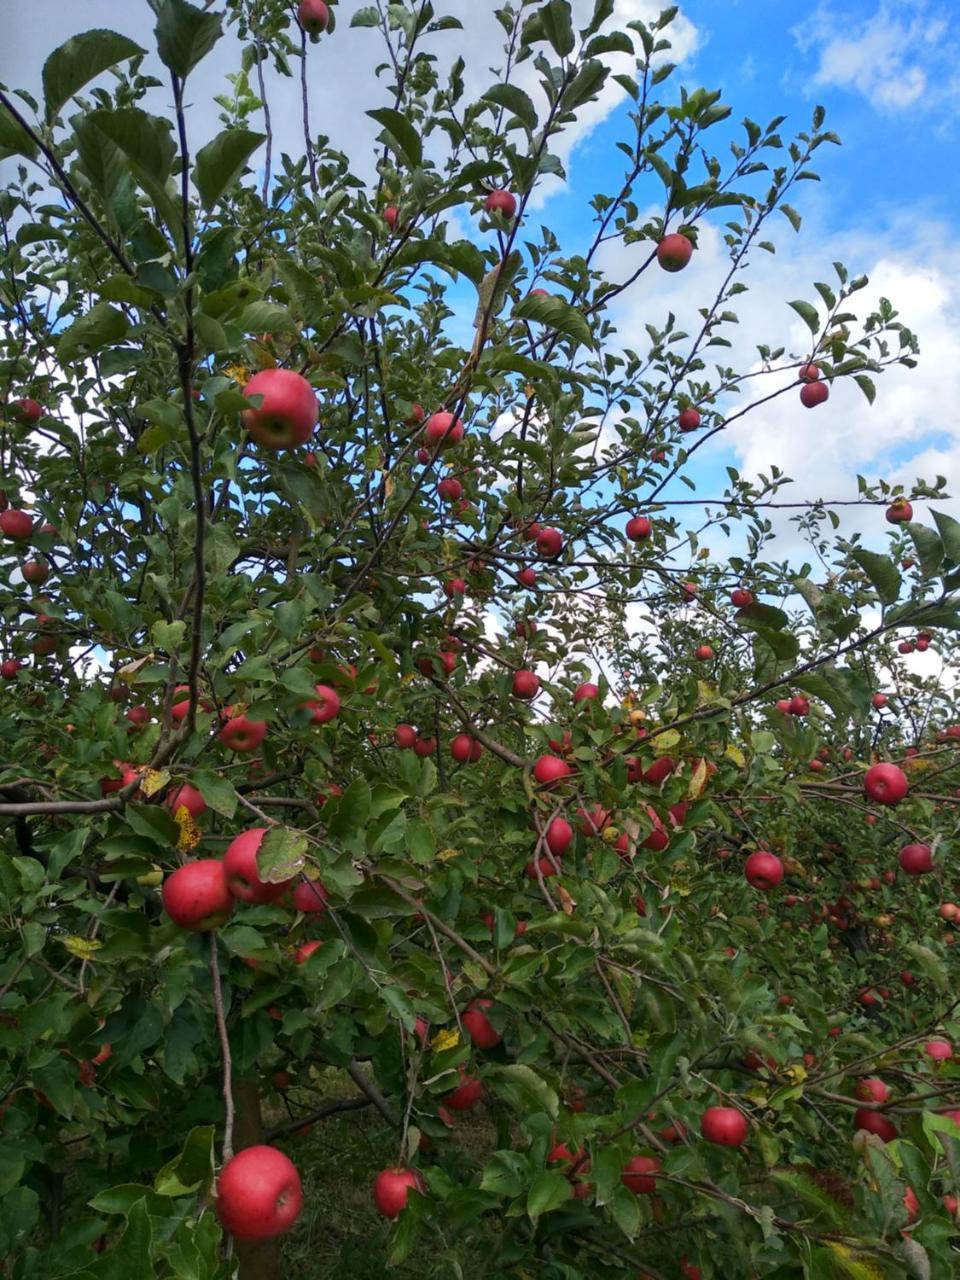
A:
[{"left": 792, "top": 0, "right": 957, "bottom": 113}]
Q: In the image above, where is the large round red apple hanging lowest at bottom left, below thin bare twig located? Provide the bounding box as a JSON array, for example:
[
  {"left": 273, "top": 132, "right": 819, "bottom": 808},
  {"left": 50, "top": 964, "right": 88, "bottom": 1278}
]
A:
[{"left": 216, "top": 1146, "right": 307, "bottom": 1240}]
